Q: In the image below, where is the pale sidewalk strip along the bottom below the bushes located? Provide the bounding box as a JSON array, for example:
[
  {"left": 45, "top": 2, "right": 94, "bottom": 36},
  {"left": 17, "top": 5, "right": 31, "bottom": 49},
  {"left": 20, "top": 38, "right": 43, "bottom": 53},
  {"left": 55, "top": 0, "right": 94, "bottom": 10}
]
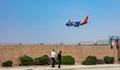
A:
[{"left": 0, "top": 64, "right": 120, "bottom": 70}]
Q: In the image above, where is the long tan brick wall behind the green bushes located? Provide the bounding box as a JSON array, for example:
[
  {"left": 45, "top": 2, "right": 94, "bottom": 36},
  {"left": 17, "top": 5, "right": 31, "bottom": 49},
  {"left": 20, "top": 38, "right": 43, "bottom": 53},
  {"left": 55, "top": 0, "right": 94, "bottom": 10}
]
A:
[{"left": 0, "top": 45, "right": 119, "bottom": 65}]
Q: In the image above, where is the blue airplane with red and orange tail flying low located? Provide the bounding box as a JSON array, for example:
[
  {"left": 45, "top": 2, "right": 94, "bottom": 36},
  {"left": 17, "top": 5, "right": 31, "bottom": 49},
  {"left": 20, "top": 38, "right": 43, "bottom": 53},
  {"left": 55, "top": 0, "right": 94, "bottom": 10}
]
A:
[{"left": 66, "top": 16, "right": 88, "bottom": 27}]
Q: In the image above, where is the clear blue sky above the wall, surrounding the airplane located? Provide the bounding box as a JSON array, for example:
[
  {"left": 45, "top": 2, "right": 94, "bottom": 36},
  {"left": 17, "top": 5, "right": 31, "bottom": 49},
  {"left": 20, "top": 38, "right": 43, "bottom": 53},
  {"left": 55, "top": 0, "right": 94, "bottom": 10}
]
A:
[{"left": 0, "top": 0, "right": 120, "bottom": 43}]
